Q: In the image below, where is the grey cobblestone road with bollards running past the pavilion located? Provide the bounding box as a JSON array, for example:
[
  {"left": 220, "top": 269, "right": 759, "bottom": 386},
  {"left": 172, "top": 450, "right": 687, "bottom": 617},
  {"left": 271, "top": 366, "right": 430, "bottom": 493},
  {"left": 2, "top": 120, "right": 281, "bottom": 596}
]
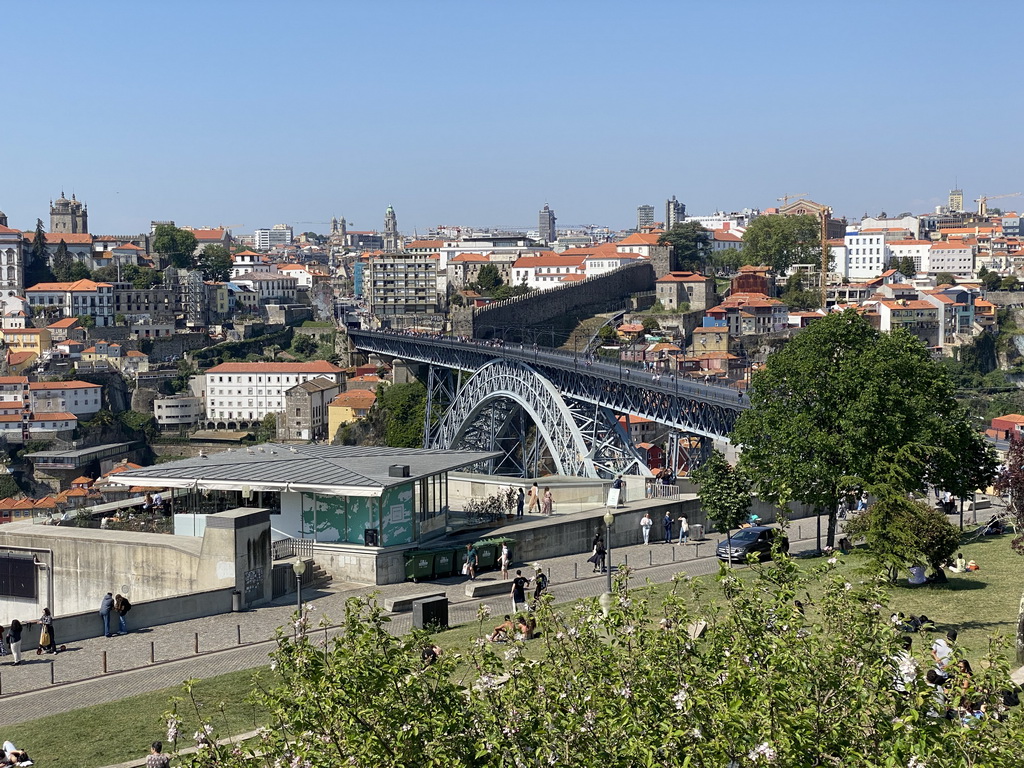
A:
[{"left": 0, "top": 512, "right": 826, "bottom": 723}]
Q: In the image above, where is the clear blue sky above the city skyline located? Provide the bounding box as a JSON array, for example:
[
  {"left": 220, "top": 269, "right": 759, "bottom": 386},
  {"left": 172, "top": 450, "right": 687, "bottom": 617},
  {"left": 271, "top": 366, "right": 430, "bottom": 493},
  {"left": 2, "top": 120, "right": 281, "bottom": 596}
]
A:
[{"left": 0, "top": 0, "right": 1024, "bottom": 233}]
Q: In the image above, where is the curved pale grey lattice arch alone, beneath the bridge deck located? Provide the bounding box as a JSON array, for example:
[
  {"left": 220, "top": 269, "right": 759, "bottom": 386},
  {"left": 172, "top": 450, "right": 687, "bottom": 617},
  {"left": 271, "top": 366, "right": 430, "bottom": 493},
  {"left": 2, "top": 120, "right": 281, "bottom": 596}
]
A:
[{"left": 431, "top": 358, "right": 646, "bottom": 477}]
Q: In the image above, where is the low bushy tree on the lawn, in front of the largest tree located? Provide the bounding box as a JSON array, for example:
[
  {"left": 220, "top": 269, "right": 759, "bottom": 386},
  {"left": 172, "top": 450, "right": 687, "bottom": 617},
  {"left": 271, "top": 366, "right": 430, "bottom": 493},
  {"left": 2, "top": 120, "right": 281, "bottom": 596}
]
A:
[{"left": 844, "top": 487, "right": 959, "bottom": 582}]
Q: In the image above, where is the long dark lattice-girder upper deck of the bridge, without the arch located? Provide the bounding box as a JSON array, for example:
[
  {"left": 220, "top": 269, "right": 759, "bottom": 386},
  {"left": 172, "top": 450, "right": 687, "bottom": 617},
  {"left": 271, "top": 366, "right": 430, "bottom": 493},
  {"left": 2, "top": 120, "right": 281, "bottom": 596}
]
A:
[{"left": 349, "top": 331, "right": 749, "bottom": 440}]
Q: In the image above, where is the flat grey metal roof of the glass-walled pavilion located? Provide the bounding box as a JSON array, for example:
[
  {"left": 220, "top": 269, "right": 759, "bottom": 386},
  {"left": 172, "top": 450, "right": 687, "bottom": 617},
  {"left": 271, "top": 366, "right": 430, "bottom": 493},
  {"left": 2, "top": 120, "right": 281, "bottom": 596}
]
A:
[{"left": 110, "top": 442, "right": 500, "bottom": 497}]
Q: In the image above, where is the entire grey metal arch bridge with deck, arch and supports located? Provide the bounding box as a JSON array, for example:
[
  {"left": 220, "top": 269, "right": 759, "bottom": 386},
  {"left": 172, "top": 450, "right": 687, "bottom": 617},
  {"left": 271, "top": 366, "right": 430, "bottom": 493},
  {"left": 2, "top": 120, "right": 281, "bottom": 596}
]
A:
[{"left": 348, "top": 330, "right": 748, "bottom": 477}]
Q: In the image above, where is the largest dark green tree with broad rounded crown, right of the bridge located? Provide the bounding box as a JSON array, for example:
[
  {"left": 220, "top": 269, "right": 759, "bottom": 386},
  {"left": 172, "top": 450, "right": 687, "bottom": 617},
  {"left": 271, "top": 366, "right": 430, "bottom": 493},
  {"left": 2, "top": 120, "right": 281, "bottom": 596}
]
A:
[{"left": 731, "top": 310, "right": 995, "bottom": 546}]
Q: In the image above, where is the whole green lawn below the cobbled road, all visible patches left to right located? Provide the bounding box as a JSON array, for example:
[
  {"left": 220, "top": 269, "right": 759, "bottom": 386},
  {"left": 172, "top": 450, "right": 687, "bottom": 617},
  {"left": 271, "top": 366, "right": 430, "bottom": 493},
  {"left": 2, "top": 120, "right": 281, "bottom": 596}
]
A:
[{"left": 6, "top": 536, "right": 1024, "bottom": 768}]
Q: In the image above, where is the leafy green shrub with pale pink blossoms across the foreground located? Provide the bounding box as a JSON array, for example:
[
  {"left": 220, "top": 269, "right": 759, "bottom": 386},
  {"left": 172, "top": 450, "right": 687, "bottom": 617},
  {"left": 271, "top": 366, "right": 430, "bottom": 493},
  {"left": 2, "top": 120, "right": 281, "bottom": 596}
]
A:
[{"left": 168, "top": 557, "right": 1024, "bottom": 768}]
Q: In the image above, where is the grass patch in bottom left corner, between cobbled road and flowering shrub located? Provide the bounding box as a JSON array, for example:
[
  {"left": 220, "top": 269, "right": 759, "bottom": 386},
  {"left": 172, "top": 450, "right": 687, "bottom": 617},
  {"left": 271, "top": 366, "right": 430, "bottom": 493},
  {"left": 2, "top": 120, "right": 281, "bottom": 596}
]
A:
[{"left": 0, "top": 670, "right": 272, "bottom": 768}]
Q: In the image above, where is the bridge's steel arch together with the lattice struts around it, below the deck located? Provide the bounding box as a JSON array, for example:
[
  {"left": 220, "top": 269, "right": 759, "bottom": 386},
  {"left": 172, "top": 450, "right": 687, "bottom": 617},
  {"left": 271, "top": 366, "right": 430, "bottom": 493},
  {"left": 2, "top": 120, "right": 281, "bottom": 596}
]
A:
[{"left": 431, "top": 359, "right": 649, "bottom": 477}]
